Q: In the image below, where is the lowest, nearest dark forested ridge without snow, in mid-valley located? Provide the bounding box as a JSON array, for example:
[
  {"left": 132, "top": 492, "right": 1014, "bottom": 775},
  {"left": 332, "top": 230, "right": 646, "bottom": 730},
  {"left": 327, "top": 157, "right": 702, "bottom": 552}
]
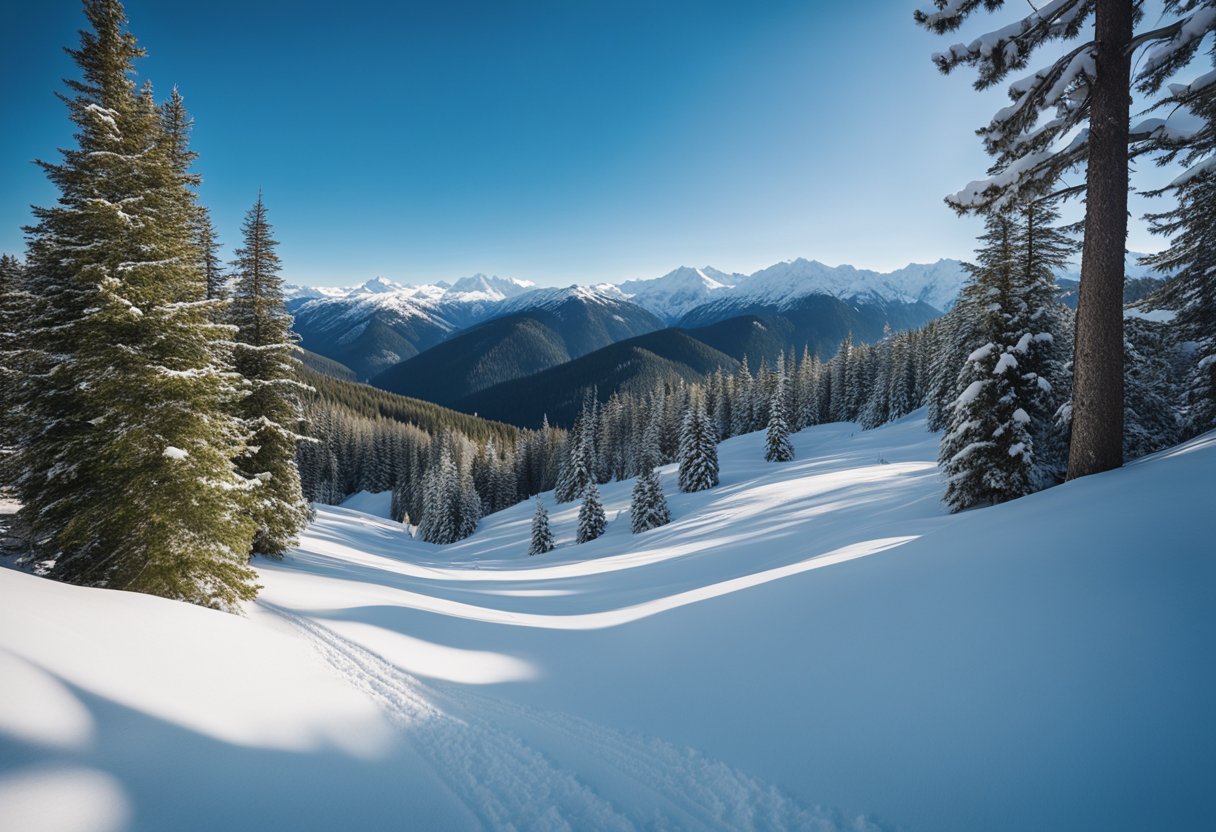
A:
[{"left": 452, "top": 328, "right": 739, "bottom": 427}]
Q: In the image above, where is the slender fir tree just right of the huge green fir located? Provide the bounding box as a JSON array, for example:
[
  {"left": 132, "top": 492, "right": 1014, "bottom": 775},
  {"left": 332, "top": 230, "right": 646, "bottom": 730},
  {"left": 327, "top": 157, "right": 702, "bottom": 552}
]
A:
[{"left": 229, "top": 193, "right": 311, "bottom": 557}]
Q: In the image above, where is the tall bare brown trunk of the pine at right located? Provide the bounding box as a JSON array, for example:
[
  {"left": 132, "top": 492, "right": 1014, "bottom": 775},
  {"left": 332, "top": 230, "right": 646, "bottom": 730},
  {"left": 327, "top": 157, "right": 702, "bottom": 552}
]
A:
[{"left": 1068, "top": 0, "right": 1132, "bottom": 479}]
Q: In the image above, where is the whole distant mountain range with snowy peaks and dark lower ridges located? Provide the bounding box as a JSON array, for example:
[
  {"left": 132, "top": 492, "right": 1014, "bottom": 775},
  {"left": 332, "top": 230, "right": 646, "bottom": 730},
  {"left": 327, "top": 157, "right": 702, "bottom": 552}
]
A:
[{"left": 288, "top": 254, "right": 1167, "bottom": 426}]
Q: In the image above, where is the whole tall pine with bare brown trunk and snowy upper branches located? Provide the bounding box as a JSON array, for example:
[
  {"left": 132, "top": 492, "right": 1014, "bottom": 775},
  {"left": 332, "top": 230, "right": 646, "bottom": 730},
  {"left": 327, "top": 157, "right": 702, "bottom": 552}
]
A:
[{"left": 914, "top": 0, "right": 1216, "bottom": 478}]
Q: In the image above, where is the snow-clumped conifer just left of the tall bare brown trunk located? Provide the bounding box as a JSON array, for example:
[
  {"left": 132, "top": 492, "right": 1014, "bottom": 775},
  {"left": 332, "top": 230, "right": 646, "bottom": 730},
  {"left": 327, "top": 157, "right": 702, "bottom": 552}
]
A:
[{"left": 939, "top": 212, "right": 1037, "bottom": 511}]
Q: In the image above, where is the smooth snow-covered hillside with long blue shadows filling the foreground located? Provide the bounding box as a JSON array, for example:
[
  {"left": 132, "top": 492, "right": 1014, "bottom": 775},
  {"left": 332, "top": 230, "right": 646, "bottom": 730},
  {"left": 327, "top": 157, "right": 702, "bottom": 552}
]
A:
[{"left": 0, "top": 414, "right": 1216, "bottom": 832}]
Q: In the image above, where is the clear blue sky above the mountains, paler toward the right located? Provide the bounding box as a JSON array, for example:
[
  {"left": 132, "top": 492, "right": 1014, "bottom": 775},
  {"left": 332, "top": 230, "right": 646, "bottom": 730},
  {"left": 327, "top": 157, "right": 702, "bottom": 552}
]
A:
[{"left": 0, "top": 0, "right": 1160, "bottom": 285}]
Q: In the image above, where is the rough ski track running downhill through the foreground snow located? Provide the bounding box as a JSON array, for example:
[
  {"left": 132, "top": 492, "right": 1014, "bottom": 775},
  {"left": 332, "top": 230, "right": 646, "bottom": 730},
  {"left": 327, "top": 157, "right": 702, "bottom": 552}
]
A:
[{"left": 266, "top": 601, "right": 880, "bottom": 832}]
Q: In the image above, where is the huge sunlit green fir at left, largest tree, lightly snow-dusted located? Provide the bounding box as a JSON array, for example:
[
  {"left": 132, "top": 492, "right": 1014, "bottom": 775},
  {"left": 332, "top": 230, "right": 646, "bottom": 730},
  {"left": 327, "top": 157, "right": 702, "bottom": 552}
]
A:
[{"left": 15, "top": 0, "right": 257, "bottom": 607}]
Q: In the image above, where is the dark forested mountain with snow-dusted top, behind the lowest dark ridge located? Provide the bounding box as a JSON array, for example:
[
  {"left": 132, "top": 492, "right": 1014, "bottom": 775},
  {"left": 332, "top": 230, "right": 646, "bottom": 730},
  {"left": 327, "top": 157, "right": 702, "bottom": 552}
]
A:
[{"left": 372, "top": 288, "right": 662, "bottom": 405}]
